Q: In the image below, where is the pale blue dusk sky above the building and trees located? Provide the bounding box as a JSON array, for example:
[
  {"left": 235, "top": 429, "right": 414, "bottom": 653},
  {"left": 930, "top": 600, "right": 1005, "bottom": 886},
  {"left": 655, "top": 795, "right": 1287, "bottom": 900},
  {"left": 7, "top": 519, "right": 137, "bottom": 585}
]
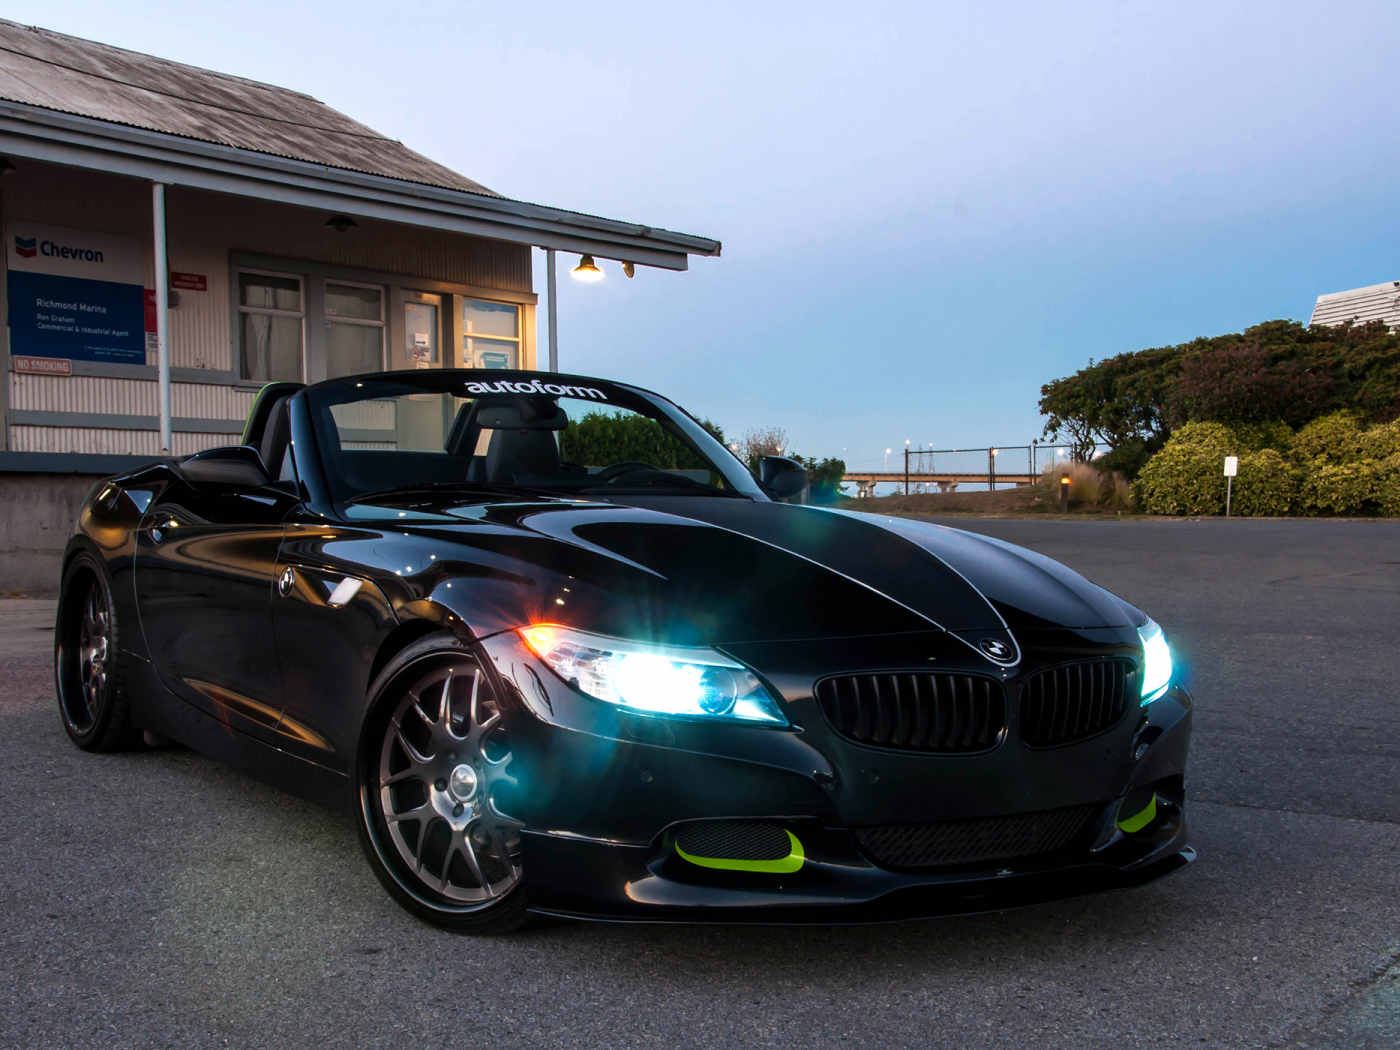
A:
[{"left": 6, "top": 0, "right": 1400, "bottom": 466}]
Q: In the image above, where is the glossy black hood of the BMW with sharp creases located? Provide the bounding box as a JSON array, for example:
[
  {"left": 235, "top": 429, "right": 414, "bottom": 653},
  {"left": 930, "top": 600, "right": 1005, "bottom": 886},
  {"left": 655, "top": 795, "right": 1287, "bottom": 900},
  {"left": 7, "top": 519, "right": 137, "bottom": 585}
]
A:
[{"left": 344, "top": 497, "right": 1141, "bottom": 649}]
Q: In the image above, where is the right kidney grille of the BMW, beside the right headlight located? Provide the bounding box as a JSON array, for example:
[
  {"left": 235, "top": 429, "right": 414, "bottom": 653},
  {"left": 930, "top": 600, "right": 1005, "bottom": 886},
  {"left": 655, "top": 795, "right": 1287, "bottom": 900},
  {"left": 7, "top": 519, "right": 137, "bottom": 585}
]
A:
[{"left": 1021, "top": 659, "right": 1137, "bottom": 748}]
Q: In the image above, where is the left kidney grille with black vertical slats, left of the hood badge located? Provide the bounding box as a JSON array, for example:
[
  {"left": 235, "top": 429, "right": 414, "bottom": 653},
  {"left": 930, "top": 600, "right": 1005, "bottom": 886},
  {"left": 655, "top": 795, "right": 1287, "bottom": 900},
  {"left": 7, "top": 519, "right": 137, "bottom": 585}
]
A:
[{"left": 816, "top": 673, "right": 1007, "bottom": 755}]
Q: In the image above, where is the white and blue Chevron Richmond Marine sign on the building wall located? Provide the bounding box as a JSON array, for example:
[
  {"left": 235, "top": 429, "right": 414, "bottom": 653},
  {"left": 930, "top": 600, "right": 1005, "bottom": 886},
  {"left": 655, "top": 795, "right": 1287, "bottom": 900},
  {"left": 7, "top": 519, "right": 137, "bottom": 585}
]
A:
[{"left": 6, "top": 220, "right": 146, "bottom": 364}]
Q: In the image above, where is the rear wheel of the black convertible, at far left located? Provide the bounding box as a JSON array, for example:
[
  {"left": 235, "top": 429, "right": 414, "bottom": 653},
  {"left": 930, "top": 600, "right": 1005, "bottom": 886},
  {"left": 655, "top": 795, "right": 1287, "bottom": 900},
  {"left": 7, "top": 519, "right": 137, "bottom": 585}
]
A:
[{"left": 53, "top": 550, "right": 141, "bottom": 752}]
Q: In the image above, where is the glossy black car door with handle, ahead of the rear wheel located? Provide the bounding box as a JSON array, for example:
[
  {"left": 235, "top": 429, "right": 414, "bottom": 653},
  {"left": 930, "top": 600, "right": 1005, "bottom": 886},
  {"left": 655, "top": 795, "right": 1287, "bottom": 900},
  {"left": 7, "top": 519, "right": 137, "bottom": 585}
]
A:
[{"left": 134, "top": 482, "right": 298, "bottom": 741}]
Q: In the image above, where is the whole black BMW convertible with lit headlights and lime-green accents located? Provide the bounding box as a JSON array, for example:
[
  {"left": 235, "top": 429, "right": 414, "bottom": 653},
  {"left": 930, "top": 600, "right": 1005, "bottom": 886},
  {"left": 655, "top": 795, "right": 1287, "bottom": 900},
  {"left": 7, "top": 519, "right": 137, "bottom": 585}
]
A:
[{"left": 55, "top": 370, "right": 1194, "bottom": 932}]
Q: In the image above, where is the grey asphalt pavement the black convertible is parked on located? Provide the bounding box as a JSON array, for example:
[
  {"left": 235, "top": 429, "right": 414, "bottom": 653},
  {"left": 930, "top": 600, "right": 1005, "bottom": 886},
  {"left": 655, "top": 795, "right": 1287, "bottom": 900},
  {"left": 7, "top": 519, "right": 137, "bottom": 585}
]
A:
[{"left": 0, "top": 521, "right": 1400, "bottom": 1050}]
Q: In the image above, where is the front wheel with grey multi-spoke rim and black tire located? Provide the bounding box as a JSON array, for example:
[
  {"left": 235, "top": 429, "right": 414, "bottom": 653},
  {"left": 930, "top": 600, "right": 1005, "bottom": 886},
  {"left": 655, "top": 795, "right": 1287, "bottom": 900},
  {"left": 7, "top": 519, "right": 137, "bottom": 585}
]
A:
[{"left": 354, "top": 634, "right": 529, "bottom": 934}]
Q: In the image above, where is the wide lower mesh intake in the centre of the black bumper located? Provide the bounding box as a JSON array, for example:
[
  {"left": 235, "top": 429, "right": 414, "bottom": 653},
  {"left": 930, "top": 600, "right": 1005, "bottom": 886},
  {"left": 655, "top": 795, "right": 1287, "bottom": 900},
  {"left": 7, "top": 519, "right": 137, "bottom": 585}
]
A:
[{"left": 851, "top": 805, "right": 1099, "bottom": 871}]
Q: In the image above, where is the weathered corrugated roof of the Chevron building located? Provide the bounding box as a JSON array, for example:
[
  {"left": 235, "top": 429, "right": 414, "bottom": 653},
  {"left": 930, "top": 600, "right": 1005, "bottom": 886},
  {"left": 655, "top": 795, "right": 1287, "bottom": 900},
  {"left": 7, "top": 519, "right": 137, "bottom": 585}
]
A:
[{"left": 0, "top": 20, "right": 500, "bottom": 196}]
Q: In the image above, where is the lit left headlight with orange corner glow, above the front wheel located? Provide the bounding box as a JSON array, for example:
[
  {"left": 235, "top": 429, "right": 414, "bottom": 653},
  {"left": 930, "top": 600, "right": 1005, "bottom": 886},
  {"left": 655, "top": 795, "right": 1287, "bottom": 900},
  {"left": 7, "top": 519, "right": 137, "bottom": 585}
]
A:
[{"left": 519, "top": 624, "right": 788, "bottom": 725}]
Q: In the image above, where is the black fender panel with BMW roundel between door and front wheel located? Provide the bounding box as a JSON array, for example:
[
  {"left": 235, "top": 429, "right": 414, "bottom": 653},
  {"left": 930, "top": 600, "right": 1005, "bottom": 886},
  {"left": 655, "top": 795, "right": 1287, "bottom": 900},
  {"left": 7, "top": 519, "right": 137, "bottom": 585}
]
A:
[{"left": 273, "top": 511, "right": 398, "bottom": 771}]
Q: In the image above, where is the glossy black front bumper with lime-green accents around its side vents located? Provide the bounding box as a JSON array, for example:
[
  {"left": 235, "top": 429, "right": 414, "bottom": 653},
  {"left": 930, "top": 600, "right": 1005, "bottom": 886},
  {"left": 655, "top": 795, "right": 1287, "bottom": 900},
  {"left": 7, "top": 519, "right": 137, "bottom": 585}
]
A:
[{"left": 483, "top": 633, "right": 1196, "bottom": 924}]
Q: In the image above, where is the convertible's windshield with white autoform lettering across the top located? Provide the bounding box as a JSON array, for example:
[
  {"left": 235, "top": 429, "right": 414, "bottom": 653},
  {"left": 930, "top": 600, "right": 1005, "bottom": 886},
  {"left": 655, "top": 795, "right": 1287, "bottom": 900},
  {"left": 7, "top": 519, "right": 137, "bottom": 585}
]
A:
[{"left": 307, "top": 370, "right": 764, "bottom": 503}]
